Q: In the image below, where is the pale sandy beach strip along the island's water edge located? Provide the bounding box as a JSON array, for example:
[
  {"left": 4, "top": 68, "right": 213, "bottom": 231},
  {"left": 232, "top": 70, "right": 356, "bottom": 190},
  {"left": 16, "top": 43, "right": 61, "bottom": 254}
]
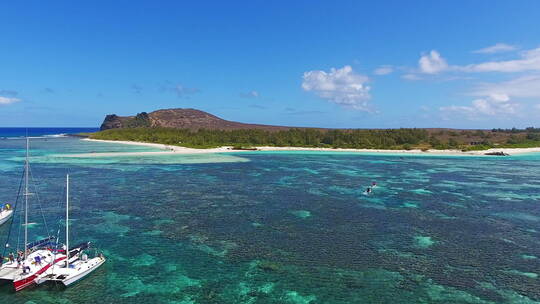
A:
[{"left": 73, "top": 138, "right": 540, "bottom": 157}]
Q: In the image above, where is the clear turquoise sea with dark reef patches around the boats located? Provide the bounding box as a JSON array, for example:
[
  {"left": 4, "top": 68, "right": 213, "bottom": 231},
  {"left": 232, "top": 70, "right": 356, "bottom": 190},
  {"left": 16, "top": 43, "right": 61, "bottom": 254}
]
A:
[{"left": 0, "top": 138, "right": 540, "bottom": 304}]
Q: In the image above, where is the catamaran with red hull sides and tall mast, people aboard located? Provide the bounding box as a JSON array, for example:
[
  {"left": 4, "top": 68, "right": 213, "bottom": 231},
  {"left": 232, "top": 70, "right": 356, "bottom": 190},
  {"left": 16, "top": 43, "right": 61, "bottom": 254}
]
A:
[{"left": 0, "top": 138, "right": 66, "bottom": 291}]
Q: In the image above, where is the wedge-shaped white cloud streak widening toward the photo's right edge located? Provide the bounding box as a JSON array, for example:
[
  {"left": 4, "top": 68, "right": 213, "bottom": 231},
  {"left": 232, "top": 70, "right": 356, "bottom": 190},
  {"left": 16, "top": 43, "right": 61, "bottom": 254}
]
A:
[{"left": 458, "top": 48, "right": 540, "bottom": 73}]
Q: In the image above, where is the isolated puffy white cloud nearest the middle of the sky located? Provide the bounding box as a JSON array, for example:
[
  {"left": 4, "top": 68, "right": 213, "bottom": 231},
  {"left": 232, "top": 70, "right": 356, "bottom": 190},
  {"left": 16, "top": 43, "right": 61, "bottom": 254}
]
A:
[{"left": 302, "top": 65, "right": 371, "bottom": 111}]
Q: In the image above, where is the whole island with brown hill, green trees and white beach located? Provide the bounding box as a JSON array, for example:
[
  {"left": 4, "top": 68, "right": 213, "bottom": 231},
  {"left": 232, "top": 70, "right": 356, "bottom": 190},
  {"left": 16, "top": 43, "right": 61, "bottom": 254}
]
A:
[{"left": 82, "top": 108, "right": 540, "bottom": 156}]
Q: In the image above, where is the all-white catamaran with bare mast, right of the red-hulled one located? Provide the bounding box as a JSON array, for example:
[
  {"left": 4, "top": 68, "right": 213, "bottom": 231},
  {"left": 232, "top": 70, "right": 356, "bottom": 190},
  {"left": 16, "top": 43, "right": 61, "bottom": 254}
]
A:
[{"left": 35, "top": 175, "right": 105, "bottom": 286}]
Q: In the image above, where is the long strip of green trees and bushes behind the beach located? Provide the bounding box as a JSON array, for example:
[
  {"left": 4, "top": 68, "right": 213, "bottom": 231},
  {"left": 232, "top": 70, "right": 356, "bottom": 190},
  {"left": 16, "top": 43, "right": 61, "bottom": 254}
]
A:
[{"left": 89, "top": 127, "right": 540, "bottom": 150}]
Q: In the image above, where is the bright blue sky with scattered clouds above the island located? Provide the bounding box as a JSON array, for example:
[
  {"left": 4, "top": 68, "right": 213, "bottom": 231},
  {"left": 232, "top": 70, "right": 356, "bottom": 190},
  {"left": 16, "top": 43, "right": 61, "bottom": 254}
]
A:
[{"left": 0, "top": 0, "right": 540, "bottom": 128}]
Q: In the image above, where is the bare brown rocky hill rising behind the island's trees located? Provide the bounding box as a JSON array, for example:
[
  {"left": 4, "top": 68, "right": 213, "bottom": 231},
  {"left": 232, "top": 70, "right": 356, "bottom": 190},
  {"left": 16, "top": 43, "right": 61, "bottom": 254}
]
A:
[{"left": 100, "top": 109, "right": 289, "bottom": 131}]
